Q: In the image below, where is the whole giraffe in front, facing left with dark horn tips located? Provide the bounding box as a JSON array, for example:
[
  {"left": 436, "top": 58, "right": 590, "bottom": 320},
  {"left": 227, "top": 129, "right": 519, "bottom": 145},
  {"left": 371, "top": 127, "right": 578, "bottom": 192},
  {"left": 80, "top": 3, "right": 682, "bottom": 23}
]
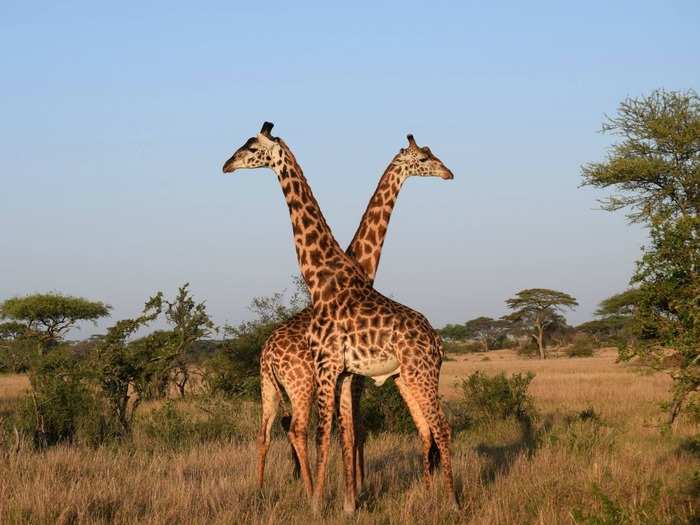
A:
[{"left": 223, "top": 122, "right": 456, "bottom": 513}]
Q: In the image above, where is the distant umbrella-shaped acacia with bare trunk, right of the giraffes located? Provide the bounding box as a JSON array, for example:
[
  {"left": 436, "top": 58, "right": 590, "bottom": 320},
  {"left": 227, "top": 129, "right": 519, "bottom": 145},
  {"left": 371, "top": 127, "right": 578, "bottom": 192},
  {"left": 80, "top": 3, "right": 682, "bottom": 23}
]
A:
[{"left": 503, "top": 288, "right": 578, "bottom": 359}]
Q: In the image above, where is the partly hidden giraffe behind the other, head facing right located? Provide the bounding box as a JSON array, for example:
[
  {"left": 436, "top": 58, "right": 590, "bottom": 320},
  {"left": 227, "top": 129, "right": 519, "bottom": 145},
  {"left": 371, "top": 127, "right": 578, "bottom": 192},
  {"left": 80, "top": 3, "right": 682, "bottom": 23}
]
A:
[{"left": 258, "top": 135, "right": 453, "bottom": 496}]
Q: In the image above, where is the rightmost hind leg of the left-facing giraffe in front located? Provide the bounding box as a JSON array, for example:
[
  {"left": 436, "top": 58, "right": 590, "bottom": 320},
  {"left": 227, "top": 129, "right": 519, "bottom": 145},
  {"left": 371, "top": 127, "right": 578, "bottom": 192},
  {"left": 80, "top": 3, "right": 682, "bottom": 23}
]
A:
[{"left": 402, "top": 368, "right": 457, "bottom": 505}]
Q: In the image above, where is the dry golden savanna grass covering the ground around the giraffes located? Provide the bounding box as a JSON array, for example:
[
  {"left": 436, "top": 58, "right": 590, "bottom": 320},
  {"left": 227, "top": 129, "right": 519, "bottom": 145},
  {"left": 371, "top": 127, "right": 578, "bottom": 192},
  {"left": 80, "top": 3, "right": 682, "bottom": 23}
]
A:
[{"left": 0, "top": 349, "right": 700, "bottom": 524}]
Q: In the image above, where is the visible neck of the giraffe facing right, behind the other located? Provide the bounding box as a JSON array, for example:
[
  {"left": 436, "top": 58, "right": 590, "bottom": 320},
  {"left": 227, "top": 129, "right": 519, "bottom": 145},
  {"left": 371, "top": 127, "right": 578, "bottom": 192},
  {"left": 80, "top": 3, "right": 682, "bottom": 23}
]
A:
[{"left": 346, "top": 166, "right": 405, "bottom": 282}]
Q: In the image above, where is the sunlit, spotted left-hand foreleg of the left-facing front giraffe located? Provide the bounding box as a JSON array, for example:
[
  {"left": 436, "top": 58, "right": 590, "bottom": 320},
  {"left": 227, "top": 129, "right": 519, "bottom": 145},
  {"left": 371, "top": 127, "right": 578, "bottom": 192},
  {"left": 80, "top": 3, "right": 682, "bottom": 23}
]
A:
[{"left": 311, "top": 362, "right": 345, "bottom": 514}]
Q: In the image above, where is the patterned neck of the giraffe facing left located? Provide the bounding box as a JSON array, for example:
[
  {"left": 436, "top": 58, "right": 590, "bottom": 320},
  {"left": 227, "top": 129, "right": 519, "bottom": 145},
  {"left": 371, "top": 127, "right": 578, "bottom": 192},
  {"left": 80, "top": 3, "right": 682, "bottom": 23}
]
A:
[{"left": 272, "top": 145, "right": 366, "bottom": 307}]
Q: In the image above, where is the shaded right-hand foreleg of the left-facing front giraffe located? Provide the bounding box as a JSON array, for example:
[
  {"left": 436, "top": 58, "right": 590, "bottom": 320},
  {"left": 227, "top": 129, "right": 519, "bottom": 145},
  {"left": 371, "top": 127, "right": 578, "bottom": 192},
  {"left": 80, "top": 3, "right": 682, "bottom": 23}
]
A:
[{"left": 338, "top": 374, "right": 357, "bottom": 514}]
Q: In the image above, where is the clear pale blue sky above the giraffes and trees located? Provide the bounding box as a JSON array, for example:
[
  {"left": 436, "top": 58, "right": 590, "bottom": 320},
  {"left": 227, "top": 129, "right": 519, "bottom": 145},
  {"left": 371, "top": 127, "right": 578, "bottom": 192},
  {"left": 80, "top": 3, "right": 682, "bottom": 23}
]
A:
[{"left": 0, "top": 0, "right": 700, "bottom": 335}]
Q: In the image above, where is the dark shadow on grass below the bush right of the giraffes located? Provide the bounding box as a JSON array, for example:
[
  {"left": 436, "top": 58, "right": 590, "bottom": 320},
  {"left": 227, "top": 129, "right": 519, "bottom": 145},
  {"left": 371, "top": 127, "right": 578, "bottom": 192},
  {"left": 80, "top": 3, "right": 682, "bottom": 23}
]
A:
[{"left": 476, "top": 416, "right": 553, "bottom": 484}]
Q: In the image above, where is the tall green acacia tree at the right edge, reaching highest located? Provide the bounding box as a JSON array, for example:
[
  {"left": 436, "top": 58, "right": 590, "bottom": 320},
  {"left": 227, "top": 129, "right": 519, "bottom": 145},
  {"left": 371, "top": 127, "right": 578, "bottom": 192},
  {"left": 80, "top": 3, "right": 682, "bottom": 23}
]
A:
[{"left": 582, "top": 90, "right": 700, "bottom": 422}]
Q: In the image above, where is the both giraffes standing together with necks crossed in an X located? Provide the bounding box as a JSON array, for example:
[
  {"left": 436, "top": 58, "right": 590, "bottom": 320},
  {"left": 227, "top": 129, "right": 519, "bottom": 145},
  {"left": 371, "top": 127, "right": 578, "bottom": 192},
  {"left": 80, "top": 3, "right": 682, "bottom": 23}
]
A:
[{"left": 223, "top": 122, "right": 456, "bottom": 512}]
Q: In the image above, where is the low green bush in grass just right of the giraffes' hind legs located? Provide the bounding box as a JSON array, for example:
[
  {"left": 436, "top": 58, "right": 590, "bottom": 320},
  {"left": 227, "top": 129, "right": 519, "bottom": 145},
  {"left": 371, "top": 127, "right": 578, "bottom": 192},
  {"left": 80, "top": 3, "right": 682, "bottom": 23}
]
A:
[{"left": 456, "top": 370, "right": 535, "bottom": 426}]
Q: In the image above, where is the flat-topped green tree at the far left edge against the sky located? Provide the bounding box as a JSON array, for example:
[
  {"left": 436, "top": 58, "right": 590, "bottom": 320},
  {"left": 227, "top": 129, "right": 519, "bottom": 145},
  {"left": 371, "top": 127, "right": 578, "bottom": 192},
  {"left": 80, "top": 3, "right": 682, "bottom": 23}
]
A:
[{"left": 0, "top": 293, "right": 111, "bottom": 353}]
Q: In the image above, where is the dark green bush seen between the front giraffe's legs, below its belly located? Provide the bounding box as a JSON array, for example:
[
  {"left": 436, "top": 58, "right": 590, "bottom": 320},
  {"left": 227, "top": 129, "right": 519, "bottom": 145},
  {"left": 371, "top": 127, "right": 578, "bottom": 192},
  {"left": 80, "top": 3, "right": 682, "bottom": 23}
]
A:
[{"left": 360, "top": 379, "right": 416, "bottom": 433}]
